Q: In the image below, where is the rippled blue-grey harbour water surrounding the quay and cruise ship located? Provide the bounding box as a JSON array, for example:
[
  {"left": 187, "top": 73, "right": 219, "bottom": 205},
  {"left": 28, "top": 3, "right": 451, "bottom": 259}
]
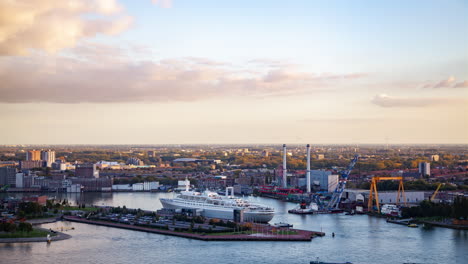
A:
[{"left": 0, "top": 193, "right": 468, "bottom": 263}]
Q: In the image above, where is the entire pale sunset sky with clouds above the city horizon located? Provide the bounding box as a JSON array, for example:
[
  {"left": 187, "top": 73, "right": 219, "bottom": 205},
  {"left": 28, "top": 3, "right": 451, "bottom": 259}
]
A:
[{"left": 0, "top": 0, "right": 468, "bottom": 144}]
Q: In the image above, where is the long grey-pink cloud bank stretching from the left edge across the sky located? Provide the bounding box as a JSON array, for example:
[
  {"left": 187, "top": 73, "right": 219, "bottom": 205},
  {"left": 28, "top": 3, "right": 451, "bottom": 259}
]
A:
[{"left": 0, "top": 46, "right": 368, "bottom": 103}]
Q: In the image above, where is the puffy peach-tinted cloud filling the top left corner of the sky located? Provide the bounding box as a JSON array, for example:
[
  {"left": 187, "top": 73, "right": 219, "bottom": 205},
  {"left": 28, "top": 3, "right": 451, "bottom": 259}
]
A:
[{"left": 0, "top": 0, "right": 133, "bottom": 55}]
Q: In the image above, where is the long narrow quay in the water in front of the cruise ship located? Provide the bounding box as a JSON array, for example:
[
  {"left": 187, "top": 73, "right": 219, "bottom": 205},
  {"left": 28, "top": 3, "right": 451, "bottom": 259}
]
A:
[{"left": 63, "top": 216, "right": 325, "bottom": 241}]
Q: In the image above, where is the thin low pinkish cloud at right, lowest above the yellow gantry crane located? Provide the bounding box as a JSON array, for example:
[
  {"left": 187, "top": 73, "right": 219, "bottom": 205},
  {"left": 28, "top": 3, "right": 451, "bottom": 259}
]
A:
[{"left": 371, "top": 94, "right": 464, "bottom": 107}]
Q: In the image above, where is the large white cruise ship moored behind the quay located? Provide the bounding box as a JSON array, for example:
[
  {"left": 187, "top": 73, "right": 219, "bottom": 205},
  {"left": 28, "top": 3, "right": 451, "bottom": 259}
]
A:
[{"left": 159, "top": 186, "right": 275, "bottom": 223}]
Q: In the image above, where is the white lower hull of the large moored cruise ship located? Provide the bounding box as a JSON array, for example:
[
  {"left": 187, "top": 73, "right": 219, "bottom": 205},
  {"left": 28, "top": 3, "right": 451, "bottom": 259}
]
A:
[{"left": 160, "top": 198, "right": 274, "bottom": 223}]
